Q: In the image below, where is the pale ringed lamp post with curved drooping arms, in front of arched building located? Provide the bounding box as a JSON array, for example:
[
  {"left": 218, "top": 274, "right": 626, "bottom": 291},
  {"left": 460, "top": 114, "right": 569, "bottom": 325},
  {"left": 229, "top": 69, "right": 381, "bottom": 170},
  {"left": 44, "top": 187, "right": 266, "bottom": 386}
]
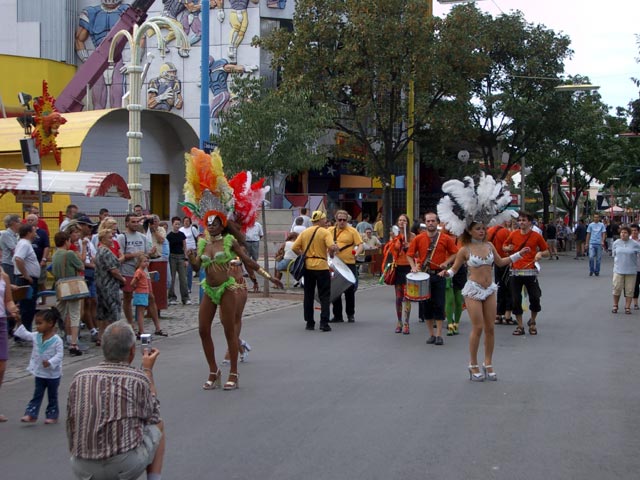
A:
[{"left": 109, "top": 17, "right": 189, "bottom": 212}]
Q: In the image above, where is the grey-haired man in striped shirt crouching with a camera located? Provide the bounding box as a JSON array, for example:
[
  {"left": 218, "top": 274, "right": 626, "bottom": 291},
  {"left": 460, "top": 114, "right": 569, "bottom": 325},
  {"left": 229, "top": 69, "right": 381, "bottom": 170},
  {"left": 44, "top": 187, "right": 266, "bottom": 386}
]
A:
[{"left": 67, "top": 321, "right": 165, "bottom": 480}]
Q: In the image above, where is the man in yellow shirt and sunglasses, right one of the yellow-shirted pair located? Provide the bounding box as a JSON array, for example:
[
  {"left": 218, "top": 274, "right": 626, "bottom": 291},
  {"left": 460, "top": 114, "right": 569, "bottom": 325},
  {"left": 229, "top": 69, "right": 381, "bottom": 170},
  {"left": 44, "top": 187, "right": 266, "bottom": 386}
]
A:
[{"left": 329, "top": 210, "right": 364, "bottom": 323}]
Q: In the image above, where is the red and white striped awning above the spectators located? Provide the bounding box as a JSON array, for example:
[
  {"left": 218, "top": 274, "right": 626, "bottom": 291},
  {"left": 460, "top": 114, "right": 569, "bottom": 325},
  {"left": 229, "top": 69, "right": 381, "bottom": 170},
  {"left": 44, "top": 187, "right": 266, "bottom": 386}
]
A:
[{"left": 0, "top": 168, "right": 131, "bottom": 199}]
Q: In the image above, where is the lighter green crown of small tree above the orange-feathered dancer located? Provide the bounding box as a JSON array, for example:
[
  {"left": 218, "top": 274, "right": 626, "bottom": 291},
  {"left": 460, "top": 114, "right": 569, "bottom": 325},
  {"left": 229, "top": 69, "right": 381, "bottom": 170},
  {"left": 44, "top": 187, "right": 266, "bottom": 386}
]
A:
[{"left": 214, "top": 79, "right": 331, "bottom": 176}]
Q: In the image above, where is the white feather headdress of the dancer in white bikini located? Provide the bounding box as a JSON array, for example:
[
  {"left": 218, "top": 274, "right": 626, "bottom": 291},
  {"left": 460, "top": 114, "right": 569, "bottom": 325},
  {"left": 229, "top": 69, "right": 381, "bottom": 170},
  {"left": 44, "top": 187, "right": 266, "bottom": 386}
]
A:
[{"left": 438, "top": 173, "right": 512, "bottom": 235}]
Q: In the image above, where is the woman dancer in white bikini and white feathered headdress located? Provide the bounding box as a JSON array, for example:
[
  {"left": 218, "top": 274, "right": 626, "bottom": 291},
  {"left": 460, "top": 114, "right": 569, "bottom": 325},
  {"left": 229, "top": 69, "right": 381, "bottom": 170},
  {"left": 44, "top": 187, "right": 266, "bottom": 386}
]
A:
[{"left": 438, "top": 175, "right": 530, "bottom": 382}]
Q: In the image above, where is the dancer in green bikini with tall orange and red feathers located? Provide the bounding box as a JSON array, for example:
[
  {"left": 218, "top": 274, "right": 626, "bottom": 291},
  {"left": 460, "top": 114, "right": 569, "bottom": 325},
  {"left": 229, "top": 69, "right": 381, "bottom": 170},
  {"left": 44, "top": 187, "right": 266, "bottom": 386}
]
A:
[{"left": 182, "top": 148, "right": 283, "bottom": 390}]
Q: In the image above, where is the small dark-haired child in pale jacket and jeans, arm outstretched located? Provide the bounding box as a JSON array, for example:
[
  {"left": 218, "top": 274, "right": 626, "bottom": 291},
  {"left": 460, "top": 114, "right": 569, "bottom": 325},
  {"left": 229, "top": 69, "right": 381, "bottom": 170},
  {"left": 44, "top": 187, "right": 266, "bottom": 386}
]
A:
[{"left": 13, "top": 307, "right": 64, "bottom": 425}]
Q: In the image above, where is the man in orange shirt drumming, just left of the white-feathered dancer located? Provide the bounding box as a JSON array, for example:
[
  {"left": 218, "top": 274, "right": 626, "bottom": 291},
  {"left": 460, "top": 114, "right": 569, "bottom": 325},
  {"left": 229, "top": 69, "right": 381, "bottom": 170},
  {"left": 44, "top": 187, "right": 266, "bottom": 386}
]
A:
[{"left": 407, "top": 212, "right": 458, "bottom": 345}]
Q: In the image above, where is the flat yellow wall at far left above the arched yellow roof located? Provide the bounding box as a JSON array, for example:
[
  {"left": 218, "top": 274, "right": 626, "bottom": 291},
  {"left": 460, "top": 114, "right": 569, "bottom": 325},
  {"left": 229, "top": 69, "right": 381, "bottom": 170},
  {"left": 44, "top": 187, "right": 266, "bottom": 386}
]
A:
[{"left": 0, "top": 55, "right": 76, "bottom": 111}]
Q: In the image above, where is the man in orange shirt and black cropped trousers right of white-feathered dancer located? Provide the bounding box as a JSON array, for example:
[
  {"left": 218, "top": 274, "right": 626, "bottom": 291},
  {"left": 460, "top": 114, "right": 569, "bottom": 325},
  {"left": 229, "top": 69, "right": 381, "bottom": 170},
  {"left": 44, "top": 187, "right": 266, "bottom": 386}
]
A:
[{"left": 502, "top": 212, "right": 549, "bottom": 335}]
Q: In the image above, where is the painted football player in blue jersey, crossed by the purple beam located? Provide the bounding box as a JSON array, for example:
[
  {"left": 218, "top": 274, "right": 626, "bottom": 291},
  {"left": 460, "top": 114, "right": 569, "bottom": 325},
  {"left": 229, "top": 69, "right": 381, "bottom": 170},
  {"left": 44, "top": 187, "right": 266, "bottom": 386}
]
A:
[{"left": 75, "top": 0, "right": 129, "bottom": 109}]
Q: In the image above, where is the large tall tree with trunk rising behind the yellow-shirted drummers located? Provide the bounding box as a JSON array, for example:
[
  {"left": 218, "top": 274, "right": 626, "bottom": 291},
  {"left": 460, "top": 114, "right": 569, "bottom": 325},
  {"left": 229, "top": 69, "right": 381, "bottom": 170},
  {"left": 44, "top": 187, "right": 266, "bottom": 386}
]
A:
[{"left": 261, "top": 0, "right": 490, "bottom": 234}]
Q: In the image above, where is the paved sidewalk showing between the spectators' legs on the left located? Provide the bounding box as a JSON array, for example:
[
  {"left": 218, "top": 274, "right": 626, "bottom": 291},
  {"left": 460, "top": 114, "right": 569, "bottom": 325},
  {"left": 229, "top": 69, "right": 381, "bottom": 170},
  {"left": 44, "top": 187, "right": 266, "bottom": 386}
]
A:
[{"left": 3, "top": 274, "right": 378, "bottom": 383}]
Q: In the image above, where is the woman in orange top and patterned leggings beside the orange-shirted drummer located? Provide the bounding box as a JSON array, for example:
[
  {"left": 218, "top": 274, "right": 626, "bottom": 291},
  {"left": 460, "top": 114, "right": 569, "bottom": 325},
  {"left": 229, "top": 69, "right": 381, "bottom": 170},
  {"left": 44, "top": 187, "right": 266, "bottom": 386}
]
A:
[{"left": 383, "top": 213, "right": 416, "bottom": 335}]
